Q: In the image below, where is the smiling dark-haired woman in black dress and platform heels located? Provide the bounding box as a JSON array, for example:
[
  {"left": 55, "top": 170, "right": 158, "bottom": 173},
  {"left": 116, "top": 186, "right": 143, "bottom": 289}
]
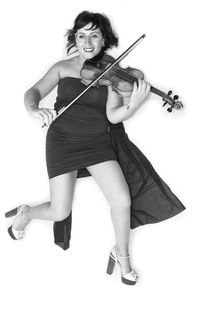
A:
[{"left": 7, "top": 11, "right": 184, "bottom": 284}]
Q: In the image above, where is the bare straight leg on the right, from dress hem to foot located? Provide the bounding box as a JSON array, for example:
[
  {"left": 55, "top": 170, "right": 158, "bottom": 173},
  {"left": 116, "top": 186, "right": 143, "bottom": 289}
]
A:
[{"left": 87, "top": 160, "right": 131, "bottom": 274}]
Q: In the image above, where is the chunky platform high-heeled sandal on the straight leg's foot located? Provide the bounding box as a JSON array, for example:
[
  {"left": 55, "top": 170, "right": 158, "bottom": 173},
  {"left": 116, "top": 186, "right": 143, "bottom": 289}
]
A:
[{"left": 106, "top": 246, "right": 138, "bottom": 285}]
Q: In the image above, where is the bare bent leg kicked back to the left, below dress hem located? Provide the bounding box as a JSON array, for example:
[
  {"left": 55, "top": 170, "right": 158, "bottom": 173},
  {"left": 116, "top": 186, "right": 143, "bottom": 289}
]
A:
[{"left": 13, "top": 170, "right": 77, "bottom": 230}]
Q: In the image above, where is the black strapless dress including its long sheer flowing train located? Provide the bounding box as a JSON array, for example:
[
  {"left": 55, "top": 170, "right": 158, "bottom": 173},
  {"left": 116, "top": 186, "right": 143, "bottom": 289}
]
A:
[{"left": 46, "top": 77, "right": 185, "bottom": 250}]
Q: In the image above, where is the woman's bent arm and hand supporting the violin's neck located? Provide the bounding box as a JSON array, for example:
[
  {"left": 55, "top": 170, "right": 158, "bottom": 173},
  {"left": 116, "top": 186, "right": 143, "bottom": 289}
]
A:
[{"left": 106, "top": 79, "right": 151, "bottom": 124}]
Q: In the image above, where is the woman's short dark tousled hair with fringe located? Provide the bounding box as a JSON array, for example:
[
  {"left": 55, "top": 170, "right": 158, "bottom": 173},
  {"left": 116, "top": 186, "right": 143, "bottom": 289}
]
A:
[{"left": 65, "top": 11, "right": 119, "bottom": 53}]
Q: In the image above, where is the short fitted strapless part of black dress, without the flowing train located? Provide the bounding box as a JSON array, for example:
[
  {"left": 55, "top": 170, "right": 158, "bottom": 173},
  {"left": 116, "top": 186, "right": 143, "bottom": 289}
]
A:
[{"left": 46, "top": 77, "right": 117, "bottom": 178}]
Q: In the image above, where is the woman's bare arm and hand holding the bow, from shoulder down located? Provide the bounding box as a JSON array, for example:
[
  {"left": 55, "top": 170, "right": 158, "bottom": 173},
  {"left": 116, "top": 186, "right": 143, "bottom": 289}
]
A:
[{"left": 24, "top": 61, "right": 63, "bottom": 126}]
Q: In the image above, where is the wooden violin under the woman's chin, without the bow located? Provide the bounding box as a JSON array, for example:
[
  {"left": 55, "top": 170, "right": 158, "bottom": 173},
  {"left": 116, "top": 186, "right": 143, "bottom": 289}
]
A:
[{"left": 80, "top": 54, "right": 183, "bottom": 112}]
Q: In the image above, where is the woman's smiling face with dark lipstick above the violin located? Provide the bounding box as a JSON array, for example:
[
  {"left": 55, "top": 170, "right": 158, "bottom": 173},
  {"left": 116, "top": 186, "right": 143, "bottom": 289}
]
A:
[{"left": 75, "top": 23, "right": 104, "bottom": 59}]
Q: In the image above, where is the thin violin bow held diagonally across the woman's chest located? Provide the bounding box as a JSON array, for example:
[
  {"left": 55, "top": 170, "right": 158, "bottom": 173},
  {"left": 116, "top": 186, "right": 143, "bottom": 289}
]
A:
[{"left": 42, "top": 34, "right": 146, "bottom": 128}]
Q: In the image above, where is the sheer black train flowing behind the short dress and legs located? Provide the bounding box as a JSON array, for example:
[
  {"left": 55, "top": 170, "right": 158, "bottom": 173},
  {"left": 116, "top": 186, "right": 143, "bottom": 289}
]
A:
[{"left": 53, "top": 122, "right": 186, "bottom": 250}]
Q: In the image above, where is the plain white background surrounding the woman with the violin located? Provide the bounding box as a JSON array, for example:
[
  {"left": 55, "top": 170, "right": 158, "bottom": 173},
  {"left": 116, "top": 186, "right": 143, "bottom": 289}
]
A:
[{"left": 0, "top": 0, "right": 200, "bottom": 315}]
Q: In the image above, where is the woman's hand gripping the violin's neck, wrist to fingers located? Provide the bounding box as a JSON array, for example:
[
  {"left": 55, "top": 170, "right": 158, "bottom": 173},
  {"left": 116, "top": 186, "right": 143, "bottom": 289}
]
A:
[{"left": 127, "top": 79, "right": 151, "bottom": 109}]
